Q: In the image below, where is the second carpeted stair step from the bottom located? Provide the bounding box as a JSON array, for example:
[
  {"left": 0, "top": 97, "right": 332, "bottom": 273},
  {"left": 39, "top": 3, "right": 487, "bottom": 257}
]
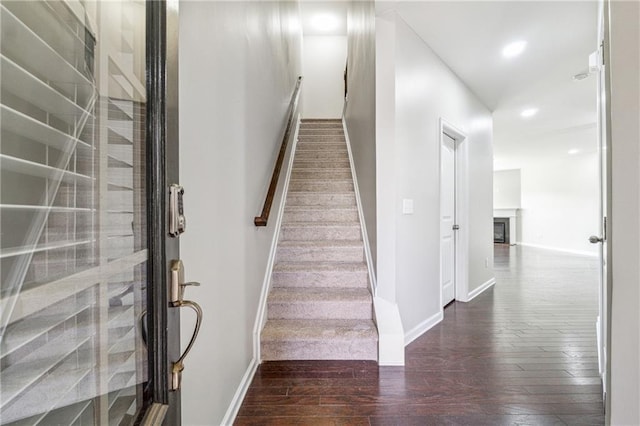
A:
[{"left": 267, "top": 287, "right": 372, "bottom": 319}]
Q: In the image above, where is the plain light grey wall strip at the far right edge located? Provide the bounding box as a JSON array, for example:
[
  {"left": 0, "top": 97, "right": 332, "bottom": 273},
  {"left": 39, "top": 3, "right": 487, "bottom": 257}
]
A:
[{"left": 609, "top": 1, "right": 640, "bottom": 426}]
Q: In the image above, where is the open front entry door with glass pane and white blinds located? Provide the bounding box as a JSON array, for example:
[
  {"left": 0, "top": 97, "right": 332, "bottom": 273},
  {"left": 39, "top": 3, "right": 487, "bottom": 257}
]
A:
[{"left": 0, "top": 0, "right": 179, "bottom": 425}]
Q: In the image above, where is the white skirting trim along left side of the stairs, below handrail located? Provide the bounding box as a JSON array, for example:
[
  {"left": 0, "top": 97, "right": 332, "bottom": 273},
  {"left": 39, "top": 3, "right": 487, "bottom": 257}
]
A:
[{"left": 253, "top": 114, "right": 300, "bottom": 360}]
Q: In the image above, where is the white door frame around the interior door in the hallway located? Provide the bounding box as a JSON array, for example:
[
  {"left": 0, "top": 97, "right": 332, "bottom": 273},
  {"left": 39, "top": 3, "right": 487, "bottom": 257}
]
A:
[{"left": 438, "top": 117, "right": 469, "bottom": 311}]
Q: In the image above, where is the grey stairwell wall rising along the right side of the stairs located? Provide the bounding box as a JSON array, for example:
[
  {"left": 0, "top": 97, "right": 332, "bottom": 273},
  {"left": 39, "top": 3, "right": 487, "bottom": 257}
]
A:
[{"left": 344, "top": 1, "right": 377, "bottom": 269}]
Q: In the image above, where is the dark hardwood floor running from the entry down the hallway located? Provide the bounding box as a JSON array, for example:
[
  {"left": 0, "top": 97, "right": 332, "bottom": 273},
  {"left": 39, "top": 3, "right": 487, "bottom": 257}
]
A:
[{"left": 235, "top": 246, "right": 604, "bottom": 426}]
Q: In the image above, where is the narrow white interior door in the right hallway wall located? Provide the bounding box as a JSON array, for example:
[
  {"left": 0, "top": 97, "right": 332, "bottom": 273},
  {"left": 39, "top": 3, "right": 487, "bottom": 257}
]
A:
[{"left": 440, "top": 133, "right": 456, "bottom": 306}]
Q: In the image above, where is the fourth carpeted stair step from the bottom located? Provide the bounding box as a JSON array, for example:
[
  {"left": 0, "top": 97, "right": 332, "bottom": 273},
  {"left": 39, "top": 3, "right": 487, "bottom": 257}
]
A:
[{"left": 276, "top": 240, "right": 364, "bottom": 263}]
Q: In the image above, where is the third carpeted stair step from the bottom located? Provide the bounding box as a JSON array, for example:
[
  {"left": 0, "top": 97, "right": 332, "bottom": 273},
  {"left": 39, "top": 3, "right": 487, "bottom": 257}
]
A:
[{"left": 271, "top": 262, "right": 369, "bottom": 288}]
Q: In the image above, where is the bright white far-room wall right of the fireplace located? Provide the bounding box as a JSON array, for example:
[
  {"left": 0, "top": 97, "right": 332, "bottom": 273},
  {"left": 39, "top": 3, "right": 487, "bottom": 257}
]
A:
[{"left": 518, "top": 136, "right": 600, "bottom": 256}]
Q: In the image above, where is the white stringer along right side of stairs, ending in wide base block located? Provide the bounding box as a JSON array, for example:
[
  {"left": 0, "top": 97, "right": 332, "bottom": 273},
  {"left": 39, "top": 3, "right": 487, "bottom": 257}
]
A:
[{"left": 342, "top": 115, "right": 405, "bottom": 366}]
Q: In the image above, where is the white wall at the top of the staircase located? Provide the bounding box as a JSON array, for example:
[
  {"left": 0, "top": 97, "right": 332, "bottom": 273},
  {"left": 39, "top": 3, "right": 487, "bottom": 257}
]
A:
[{"left": 302, "top": 35, "right": 347, "bottom": 118}]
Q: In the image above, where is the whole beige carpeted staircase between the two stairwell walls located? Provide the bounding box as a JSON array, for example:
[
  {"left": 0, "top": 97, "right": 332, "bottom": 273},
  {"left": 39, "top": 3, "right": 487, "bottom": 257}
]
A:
[{"left": 261, "top": 120, "right": 378, "bottom": 361}]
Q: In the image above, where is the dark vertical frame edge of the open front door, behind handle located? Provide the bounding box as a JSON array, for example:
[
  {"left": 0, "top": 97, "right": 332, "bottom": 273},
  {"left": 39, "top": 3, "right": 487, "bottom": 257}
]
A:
[{"left": 141, "top": 0, "right": 181, "bottom": 425}]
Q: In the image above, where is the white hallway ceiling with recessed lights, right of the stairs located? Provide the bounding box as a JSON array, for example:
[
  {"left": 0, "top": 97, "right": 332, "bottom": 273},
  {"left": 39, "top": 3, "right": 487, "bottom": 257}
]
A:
[{"left": 396, "top": 1, "right": 597, "bottom": 168}]
